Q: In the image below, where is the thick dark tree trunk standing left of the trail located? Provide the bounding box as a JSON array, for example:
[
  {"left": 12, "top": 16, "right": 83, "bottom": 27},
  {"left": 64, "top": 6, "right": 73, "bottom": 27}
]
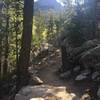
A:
[{"left": 18, "top": 0, "right": 33, "bottom": 88}]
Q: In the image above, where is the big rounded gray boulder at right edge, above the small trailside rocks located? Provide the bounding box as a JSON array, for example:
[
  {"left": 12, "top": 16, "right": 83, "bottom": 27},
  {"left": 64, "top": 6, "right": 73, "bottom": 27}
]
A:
[{"left": 79, "top": 45, "right": 100, "bottom": 70}]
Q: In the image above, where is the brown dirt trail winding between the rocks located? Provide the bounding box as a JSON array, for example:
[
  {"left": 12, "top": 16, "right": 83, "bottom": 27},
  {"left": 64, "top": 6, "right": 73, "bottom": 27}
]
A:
[{"left": 36, "top": 49, "right": 98, "bottom": 100}]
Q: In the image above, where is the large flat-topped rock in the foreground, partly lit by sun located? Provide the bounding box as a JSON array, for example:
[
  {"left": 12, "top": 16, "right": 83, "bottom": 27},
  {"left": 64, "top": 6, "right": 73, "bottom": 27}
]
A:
[{"left": 15, "top": 85, "right": 79, "bottom": 100}]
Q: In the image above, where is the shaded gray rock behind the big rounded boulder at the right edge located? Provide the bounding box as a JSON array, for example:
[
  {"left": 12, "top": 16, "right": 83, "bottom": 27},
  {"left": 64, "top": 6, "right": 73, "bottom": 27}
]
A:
[{"left": 62, "top": 39, "right": 100, "bottom": 63}]
